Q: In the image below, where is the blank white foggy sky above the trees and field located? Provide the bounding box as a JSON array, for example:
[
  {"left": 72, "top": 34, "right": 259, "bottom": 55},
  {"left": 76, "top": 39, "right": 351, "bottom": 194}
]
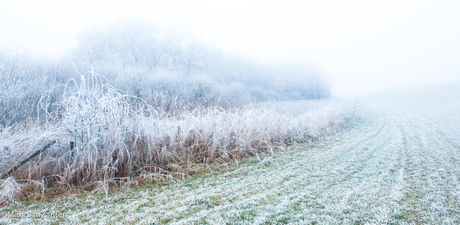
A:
[{"left": 0, "top": 0, "right": 460, "bottom": 97}]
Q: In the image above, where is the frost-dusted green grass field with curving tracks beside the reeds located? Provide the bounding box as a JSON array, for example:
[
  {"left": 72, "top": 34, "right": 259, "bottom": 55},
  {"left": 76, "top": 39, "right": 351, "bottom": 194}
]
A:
[{"left": 0, "top": 84, "right": 460, "bottom": 224}]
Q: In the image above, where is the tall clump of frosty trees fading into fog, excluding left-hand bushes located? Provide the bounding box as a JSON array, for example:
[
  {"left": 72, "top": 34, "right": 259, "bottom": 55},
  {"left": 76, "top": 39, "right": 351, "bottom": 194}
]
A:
[{"left": 69, "top": 19, "right": 329, "bottom": 104}]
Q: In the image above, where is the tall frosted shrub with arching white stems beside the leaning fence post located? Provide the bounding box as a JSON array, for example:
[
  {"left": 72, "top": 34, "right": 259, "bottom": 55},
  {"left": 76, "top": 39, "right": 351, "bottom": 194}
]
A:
[{"left": 41, "top": 72, "right": 149, "bottom": 183}]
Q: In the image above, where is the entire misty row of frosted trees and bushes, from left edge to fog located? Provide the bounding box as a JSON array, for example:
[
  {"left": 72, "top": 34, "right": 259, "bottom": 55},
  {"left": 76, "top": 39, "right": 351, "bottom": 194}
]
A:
[{"left": 0, "top": 20, "right": 330, "bottom": 128}]
